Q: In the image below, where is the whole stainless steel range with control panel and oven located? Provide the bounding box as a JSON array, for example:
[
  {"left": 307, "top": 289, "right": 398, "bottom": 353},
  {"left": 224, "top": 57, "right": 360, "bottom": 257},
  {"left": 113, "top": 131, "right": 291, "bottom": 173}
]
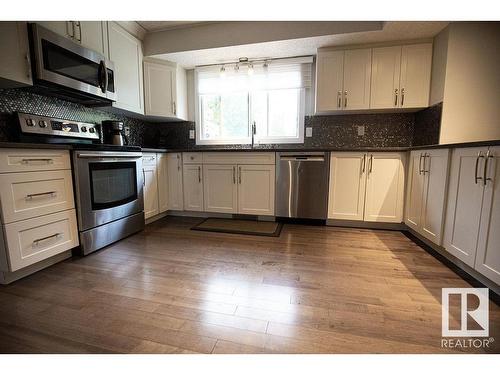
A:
[{"left": 18, "top": 113, "right": 144, "bottom": 255}]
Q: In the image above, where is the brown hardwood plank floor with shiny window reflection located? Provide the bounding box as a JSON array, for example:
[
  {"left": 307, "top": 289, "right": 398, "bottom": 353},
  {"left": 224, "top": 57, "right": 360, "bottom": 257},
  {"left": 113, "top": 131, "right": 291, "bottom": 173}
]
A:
[{"left": 0, "top": 218, "right": 500, "bottom": 353}]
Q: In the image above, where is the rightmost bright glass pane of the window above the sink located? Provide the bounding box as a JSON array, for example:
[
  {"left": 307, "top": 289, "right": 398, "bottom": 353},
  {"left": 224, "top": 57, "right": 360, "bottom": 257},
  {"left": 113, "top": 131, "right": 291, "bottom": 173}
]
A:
[{"left": 267, "top": 89, "right": 300, "bottom": 137}]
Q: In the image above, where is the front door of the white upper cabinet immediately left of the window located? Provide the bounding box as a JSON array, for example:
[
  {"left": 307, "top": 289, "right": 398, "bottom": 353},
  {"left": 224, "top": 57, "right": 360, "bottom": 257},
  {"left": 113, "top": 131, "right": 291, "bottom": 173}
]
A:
[{"left": 144, "top": 60, "right": 176, "bottom": 117}]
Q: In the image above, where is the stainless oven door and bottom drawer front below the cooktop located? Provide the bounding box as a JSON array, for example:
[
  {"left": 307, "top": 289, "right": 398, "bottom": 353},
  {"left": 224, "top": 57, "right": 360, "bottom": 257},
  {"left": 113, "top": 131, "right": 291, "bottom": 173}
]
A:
[{"left": 73, "top": 150, "right": 144, "bottom": 255}]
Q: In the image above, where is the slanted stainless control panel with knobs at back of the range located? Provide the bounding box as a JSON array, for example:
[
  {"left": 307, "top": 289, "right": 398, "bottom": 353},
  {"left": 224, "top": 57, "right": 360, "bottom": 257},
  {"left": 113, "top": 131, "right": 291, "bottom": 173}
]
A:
[{"left": 18, "top": 112, "right": 99, "bottom": 139}]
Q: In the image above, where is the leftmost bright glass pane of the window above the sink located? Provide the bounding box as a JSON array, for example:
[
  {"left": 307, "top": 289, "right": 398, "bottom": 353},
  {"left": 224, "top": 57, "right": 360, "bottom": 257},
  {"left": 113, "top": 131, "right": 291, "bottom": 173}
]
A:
[{"left": 200, "top": 93, "right": 249, "bottom": 139}]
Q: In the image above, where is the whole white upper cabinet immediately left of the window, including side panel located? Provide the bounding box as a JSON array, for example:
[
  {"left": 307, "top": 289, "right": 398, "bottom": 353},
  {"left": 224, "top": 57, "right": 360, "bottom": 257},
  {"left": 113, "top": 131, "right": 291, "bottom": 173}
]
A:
[{"left": 144, "top": 59, "right": 187, "bottom": 120}]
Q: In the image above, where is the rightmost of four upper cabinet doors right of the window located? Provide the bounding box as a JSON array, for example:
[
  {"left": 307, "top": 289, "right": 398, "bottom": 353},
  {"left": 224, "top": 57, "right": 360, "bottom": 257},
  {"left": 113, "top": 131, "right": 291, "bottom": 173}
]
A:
[{"left": 400, "top": 43, "right": 432, "bottom": 108}]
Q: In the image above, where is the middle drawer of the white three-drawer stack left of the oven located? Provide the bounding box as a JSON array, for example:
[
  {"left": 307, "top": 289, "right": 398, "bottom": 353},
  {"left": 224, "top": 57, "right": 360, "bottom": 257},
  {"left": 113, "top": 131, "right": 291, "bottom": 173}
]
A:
[{"left": 0, "top": 170, "right": 75, "bottom": 224}]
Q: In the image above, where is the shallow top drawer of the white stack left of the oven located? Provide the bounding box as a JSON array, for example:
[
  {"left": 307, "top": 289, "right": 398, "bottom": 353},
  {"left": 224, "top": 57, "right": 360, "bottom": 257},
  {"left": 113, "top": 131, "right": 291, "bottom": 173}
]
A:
[{"left": 0, "top": 149, "right": 71, "bottom": 173}]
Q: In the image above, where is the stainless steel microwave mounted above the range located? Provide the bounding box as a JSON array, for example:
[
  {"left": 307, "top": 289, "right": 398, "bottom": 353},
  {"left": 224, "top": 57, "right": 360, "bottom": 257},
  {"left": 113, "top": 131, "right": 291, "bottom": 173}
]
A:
[{"left": 29, "top": 23, "right": 116, "bottom": 106}]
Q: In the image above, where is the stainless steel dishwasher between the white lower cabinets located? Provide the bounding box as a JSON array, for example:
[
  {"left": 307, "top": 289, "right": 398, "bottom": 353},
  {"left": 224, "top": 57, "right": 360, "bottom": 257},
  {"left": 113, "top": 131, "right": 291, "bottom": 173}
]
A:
[{"left": 276, "top": 152, "right": 330, "bottom": 219}]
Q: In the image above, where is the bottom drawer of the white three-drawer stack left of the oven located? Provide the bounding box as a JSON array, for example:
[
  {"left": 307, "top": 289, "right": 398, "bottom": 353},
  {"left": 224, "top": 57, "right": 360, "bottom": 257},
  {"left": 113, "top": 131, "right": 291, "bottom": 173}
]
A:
[{"left": 4, "top": 209, "right": 78, "bottom": 271}]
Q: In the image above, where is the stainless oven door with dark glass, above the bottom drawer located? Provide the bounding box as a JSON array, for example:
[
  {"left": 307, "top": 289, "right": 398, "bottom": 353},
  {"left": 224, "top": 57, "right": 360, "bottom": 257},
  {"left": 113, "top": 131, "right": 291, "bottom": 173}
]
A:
[{"left": 73, "top": 151, "right": 144, "bottom": 231}]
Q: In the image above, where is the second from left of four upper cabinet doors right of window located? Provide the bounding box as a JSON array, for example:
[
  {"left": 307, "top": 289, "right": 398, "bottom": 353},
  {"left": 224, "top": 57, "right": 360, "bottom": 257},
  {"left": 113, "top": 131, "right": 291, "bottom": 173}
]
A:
[{"left": 343, "top": 48, "right": 372, "bottom": 109}]
